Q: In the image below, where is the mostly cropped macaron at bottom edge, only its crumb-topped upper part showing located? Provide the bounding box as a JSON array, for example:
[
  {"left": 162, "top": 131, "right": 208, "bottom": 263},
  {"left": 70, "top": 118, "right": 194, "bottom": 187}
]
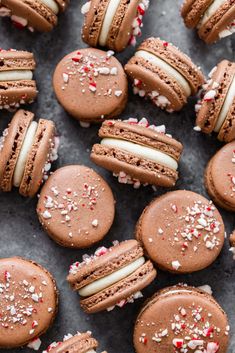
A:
[{"left": 42, "top": 332, "right": 107, "bottom": 353}]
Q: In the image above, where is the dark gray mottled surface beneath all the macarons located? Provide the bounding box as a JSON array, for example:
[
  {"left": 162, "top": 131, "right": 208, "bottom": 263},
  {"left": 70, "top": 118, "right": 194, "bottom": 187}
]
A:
[{"left": 0, "top": 0, "right": 235, "bottom": 353}]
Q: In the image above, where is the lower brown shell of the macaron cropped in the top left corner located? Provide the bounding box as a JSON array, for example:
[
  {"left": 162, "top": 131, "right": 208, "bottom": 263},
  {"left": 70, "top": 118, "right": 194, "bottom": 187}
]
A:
[{"left": 1, "top": 0, "right": 57, "bottom": 32}]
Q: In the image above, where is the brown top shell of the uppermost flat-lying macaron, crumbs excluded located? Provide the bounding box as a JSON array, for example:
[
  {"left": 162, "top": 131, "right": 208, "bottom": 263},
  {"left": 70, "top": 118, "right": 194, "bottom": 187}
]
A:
[{"left": 53, "top": 48, "right": 128, "bottom": 122}]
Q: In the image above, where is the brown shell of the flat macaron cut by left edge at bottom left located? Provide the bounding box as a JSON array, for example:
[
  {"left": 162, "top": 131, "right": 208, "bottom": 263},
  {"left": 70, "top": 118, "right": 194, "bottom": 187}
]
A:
[{"left": 0, "top": 257, "right": 58, "bottom": 348}]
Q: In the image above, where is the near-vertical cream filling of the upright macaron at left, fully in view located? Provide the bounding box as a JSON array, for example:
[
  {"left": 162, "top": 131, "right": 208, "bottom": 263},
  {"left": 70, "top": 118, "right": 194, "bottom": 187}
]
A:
[{"left": 13, "top": 121, "right": 38, "bottom": 187}]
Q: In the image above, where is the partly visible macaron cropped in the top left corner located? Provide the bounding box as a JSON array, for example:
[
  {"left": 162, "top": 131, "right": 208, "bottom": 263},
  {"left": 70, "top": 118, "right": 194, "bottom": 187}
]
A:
[{"left": 0, "top": 0, "right": 69, "bottom": 32}]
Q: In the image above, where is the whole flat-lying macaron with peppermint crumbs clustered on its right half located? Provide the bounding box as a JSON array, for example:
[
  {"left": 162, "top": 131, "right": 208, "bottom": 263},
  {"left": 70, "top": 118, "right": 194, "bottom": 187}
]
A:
[{"left": 136, "top": 190, "right": 225, "bottom": 273}]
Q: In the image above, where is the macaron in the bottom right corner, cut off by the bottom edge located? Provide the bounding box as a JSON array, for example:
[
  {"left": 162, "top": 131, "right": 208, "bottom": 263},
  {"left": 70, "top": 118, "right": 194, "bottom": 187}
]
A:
[{"left": 134, "top": 285, "right": 229, "bottom": 353}]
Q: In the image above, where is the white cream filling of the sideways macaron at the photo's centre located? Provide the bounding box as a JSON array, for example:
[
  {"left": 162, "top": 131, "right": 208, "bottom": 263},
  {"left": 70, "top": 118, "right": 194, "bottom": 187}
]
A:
[{"left": 101, "top": 138, "right": 178, "bottom": 170}]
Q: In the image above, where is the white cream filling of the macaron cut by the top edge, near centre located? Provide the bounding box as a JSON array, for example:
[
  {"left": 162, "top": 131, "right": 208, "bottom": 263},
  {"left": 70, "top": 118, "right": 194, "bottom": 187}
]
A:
[{"left": 99, "top": 0, "right": 121, "bottom": 46}]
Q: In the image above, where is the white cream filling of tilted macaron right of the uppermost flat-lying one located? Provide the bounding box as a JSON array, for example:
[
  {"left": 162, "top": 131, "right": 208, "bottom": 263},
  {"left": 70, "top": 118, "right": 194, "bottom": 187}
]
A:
[{"left": 135, "top": 50, "right": 191, "bottom": 96}]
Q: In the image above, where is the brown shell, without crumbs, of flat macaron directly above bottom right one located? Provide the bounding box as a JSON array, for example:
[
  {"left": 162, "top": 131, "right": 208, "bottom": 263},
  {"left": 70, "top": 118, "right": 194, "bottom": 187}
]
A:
[{"left": 136, "top": 190, "right": 224, "bottom": 273}]
